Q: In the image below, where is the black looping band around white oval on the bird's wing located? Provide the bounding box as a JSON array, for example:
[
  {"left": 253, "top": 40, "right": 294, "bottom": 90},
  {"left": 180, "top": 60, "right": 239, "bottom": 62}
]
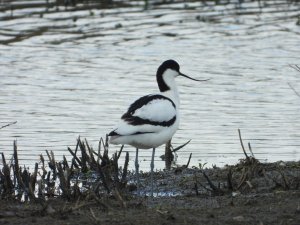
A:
[{"left": 121, "top": 95, "right": 176, "bottom": 127}]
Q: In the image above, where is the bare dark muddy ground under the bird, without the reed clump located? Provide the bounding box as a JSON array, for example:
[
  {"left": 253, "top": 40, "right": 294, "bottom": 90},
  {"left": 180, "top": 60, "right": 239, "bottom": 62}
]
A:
[{"left": 0, "top": 160, "right": 300, "bottom": 225}]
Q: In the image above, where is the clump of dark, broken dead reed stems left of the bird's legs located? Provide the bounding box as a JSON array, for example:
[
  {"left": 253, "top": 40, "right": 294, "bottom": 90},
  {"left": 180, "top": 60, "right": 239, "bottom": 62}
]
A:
[{"left": 0, "top": 138, "right": 129, "bottom": 201}]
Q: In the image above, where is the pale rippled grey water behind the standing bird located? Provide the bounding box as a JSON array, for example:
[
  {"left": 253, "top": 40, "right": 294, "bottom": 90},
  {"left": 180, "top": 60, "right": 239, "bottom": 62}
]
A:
[{"left": 0, "top": 1, "right": 300, "bottom": 170}]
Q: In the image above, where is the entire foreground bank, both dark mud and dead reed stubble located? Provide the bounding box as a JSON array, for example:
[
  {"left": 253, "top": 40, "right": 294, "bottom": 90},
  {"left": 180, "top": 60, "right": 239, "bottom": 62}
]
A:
[{"left": 0, "top": 139, "right": 300, "bottom": 225}]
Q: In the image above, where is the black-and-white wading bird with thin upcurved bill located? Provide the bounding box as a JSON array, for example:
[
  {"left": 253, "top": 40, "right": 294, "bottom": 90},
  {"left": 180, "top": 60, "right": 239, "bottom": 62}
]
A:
[{"left": 108, "top": 59, "right": 206, "bottom": 196}]
